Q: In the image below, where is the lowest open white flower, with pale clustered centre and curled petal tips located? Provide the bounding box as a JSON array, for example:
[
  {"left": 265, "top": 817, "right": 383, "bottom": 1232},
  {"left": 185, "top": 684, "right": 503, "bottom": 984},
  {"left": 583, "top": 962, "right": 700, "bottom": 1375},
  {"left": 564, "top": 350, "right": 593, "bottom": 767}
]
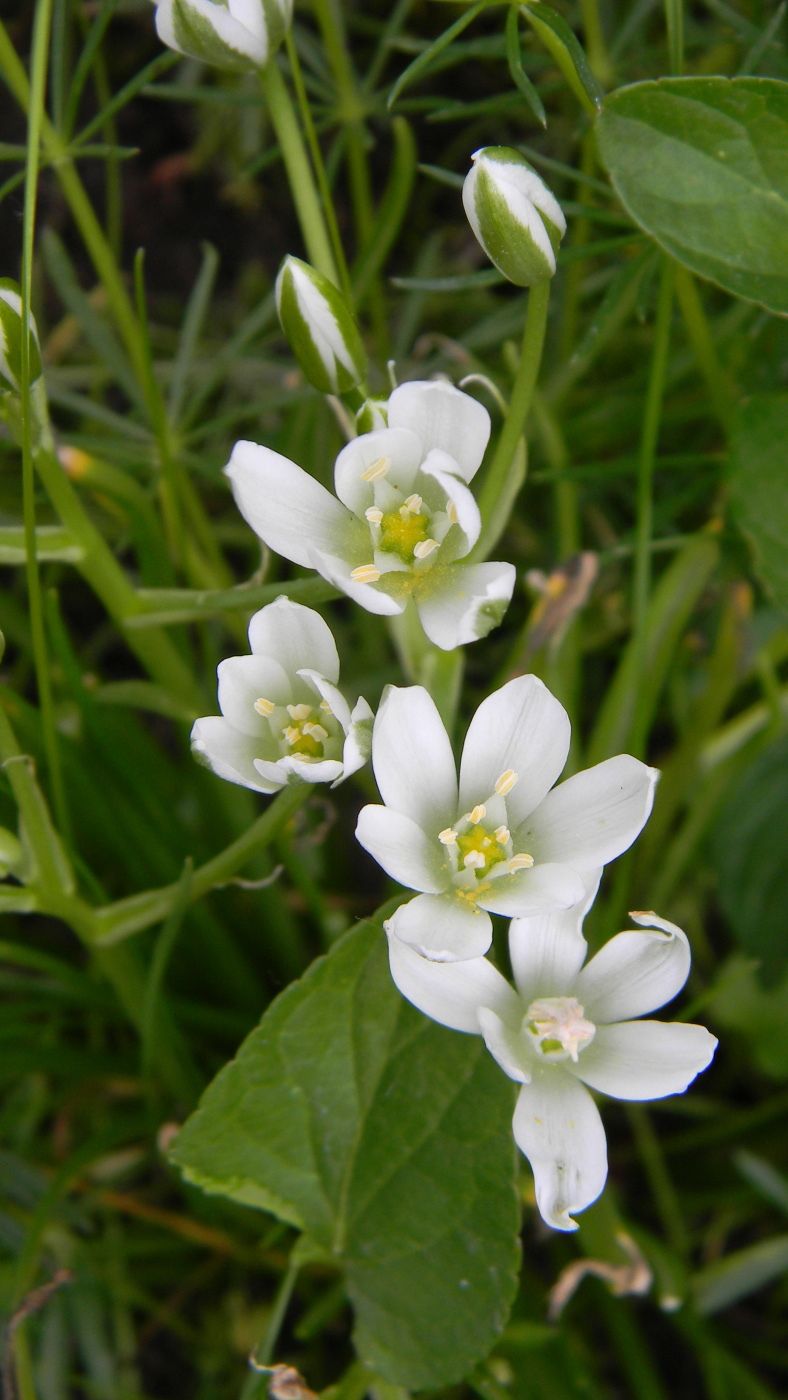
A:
[{"left": 389, "top": 872, "right": 717, "bottom": 1231}]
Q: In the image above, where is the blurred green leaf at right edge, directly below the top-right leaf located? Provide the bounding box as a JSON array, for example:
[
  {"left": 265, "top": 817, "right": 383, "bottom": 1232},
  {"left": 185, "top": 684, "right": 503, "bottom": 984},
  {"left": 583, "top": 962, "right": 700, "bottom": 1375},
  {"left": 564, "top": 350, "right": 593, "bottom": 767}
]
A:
[{"left": 728, "top": 393, "right": 788, "bottom": 612}]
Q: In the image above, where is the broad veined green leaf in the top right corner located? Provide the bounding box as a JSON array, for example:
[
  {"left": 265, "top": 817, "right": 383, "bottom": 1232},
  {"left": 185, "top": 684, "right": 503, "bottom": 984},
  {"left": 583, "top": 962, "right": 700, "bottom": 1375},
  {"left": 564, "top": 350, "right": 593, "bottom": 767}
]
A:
[{"left": 596, "top": 77, "right": 788, "bottom": 314}]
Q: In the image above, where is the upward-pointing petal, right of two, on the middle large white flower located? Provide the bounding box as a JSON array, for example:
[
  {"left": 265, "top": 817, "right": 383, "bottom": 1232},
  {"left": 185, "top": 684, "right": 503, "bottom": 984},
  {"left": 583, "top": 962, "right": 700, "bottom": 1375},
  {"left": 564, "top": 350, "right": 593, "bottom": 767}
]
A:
[{"left": 459, "top": 676, "right": 571, "bottom": 823}]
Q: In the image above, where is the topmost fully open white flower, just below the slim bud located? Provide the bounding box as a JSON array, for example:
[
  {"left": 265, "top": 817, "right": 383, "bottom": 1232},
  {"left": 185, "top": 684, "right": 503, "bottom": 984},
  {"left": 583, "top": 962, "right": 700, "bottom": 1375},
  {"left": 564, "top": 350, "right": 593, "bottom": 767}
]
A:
[{"left": 225, "top": 382, "right": 515, "bottom": 651}]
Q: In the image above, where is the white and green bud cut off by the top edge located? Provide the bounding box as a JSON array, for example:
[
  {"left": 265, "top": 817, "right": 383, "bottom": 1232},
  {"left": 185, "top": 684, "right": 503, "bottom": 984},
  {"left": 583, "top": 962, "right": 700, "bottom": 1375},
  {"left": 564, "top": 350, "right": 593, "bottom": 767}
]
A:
[{"left": 155, "top": 0, "right": 293, "bottom": 70}]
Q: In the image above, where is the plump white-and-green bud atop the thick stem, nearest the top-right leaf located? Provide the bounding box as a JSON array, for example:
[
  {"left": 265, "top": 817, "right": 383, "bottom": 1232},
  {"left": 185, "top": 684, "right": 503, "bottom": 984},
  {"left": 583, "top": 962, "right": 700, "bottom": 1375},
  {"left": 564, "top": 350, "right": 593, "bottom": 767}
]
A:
[{"left": 462, "top": 146, "right": 567, "bottom": 287}]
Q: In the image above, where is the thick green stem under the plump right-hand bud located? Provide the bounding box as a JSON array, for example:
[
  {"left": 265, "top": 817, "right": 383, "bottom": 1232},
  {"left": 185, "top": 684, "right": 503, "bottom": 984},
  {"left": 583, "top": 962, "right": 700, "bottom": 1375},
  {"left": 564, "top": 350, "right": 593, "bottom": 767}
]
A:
[{"left": 472, "top": 280, "right": 550, "bottom": 560}]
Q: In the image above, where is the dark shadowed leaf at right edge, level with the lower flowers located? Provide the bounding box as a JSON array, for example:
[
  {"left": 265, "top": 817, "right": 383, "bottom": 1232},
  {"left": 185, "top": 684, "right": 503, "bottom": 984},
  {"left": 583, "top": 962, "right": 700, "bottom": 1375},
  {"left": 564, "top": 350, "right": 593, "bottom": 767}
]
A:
[{"left": 711, "top": 738, "right": 788, "bottom": 981}]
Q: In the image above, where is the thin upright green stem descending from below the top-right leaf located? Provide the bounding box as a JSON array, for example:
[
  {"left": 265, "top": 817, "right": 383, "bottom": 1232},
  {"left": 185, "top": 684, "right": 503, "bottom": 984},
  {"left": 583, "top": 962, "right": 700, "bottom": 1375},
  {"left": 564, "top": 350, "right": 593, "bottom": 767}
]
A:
[{"left": 633, "top": 256, "right": 676, "bottom": 722}]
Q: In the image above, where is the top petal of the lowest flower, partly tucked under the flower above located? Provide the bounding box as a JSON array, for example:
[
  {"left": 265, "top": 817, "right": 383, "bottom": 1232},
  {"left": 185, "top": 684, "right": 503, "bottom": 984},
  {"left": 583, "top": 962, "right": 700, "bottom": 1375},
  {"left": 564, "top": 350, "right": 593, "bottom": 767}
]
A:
[{"left": 509, "top": 871, "right": 602, "bottom": 1002}]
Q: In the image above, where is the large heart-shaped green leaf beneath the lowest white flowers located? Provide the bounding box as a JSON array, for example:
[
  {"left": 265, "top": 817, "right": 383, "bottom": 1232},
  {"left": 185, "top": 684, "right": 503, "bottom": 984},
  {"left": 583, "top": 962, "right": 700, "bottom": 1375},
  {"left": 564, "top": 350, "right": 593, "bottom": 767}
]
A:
[{"left": 172, "top": 924, "right": 518, "bottom": 1390}]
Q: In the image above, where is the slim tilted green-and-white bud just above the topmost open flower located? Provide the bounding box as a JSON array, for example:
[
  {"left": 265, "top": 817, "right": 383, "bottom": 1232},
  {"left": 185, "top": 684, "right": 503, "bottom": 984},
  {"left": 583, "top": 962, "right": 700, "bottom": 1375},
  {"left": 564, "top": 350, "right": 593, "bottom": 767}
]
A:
[{"left": 276, "top": 256, "right": 367, "bottom": 393}]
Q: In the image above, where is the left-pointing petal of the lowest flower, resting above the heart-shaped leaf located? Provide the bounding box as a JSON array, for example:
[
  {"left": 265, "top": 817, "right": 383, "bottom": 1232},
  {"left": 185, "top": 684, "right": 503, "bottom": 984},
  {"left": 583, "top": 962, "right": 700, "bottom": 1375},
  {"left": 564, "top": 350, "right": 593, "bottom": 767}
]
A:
[{"left": 386, "top": 923, "right": 518, "bottom": 1035}]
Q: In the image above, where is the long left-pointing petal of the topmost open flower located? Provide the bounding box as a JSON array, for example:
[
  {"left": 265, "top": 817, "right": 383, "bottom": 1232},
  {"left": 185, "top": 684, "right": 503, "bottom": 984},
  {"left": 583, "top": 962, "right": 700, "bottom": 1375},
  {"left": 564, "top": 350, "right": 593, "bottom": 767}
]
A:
[{"left": 217, "top": 439, "right": 364, "bottom": 568}]
